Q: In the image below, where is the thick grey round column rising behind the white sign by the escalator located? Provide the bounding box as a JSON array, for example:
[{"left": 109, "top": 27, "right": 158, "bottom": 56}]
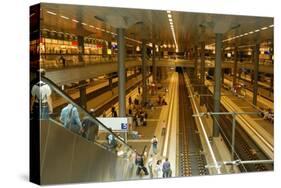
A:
[{"left": 117, "top": 28, "right": 126, "bottom": 117}]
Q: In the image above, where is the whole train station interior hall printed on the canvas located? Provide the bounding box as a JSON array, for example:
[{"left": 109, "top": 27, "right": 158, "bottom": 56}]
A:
[{"left": 30, "top": 3, "right": 274, "bottom": 184}]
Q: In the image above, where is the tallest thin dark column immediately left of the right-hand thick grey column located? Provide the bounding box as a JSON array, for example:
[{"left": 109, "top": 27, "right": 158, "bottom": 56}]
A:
[{"left": 200, "top": 42, "right": 205, "bottom": 105}]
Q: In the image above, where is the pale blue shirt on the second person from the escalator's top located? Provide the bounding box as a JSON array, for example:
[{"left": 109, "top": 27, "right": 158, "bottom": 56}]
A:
[{"left": 60, "top": 105, "right": 81, "bottom": 128}]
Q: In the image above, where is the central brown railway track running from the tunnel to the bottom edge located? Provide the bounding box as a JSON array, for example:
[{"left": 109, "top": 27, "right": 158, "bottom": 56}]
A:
[{"left": 178, "top": 72, "right": 209, "bottom": 176}]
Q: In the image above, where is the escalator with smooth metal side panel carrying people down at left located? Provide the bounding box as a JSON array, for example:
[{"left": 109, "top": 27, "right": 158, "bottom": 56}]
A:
[{"left": 35, "top": 78, "right": 136, "bottom": 185}]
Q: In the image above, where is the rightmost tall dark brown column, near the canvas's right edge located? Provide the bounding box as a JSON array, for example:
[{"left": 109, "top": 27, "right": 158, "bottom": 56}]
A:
[{"left": 253, "top": 44, "right": 260, "bottom": 105}]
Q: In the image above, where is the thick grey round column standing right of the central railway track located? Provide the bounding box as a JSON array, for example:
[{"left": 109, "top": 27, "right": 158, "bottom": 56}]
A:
[{"left": 213, "top": 33, "right": 222, "bottom": 137}]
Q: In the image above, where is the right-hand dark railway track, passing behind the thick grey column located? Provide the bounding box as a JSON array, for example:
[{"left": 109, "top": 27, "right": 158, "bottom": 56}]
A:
[{"left": 185, "top": 68, "right": 273, "bottom": 172}]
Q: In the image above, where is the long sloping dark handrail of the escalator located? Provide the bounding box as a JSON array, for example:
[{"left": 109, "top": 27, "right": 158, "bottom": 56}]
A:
[{"left": 41, "top": 76, "right": 134, "bottom": 151}]
